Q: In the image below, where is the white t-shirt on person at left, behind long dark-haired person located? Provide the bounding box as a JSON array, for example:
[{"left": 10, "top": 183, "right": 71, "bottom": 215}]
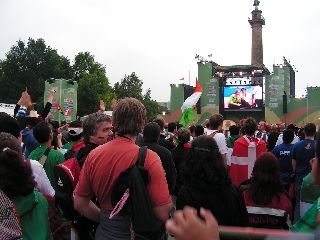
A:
[{"left": 30, "top": 160, "right": 55, "bottom": 197}]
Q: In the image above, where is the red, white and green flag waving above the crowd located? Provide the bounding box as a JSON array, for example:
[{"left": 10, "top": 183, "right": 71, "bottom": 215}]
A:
[{"left": 181, "top": 79, "right": 202, "bottom": 127}]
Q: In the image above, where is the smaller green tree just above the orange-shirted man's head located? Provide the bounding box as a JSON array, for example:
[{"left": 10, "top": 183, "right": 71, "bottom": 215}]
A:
[{"left": 114, "top": 72, "right": 158, "bottom": 121}]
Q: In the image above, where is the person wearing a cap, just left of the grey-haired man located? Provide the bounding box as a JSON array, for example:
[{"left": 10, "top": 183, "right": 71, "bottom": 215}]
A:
[{"left": 60, "top": 120, "right": 84, "bottom": 160}]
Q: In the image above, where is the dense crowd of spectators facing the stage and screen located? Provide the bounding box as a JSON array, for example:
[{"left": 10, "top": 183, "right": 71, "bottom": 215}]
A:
[{"left": 0, "top": 90, "right": 320, "bottom": 240}]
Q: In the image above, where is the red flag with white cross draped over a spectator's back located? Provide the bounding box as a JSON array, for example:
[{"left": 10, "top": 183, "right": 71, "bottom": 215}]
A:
[{"left": 230, "top": 136, "right": 267, "bottom": 186}]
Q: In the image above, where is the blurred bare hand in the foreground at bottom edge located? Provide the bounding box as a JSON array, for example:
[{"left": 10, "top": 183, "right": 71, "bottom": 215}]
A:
[{"left": 166, "top": 206, "right": 219, "bottom": 240}]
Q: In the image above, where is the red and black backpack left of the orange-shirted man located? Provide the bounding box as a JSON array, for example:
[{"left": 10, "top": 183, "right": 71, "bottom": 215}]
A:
[{"left": 53, "top": 151, "right": 80, "bottom": 221}]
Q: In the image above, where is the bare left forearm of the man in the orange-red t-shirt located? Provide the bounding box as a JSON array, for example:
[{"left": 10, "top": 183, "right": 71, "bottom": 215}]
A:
[{"left": 74, "top": 194, "right": 100, "bottom": 222}]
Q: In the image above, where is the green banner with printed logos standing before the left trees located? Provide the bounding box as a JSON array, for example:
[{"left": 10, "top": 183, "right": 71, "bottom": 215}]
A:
[{"left": 44, "top": 79, "right": 78, "bottom": 122}]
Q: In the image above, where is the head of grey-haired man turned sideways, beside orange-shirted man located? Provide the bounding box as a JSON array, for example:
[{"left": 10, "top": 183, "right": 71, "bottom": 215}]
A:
[{"left": 82, "top": 113, "right": 113, "bottom": 145}]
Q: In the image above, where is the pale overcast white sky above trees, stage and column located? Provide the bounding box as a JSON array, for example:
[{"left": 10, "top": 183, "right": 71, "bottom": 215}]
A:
[{"left": 0, "top": 0, "right": 320, "bottom": 102}]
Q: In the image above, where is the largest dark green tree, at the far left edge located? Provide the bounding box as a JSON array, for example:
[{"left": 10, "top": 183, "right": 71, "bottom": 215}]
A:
[{"left": 0, "top": 38, "right": 72, "bottom": 109}]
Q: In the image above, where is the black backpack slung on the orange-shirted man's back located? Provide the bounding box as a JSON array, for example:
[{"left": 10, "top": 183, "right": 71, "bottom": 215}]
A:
[{"left": 110, "top": 146, "right": 165, "bottom": 240}]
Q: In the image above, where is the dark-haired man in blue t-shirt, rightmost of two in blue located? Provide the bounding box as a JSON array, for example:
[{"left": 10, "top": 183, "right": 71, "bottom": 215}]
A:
[{"left": 291, "top": 123, "right": 316, "bottom": 223}]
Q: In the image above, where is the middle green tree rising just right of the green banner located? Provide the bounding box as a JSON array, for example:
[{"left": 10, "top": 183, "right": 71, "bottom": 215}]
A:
[{"left": 72, "top": 52, "right": 117, "bottom": 116}]
